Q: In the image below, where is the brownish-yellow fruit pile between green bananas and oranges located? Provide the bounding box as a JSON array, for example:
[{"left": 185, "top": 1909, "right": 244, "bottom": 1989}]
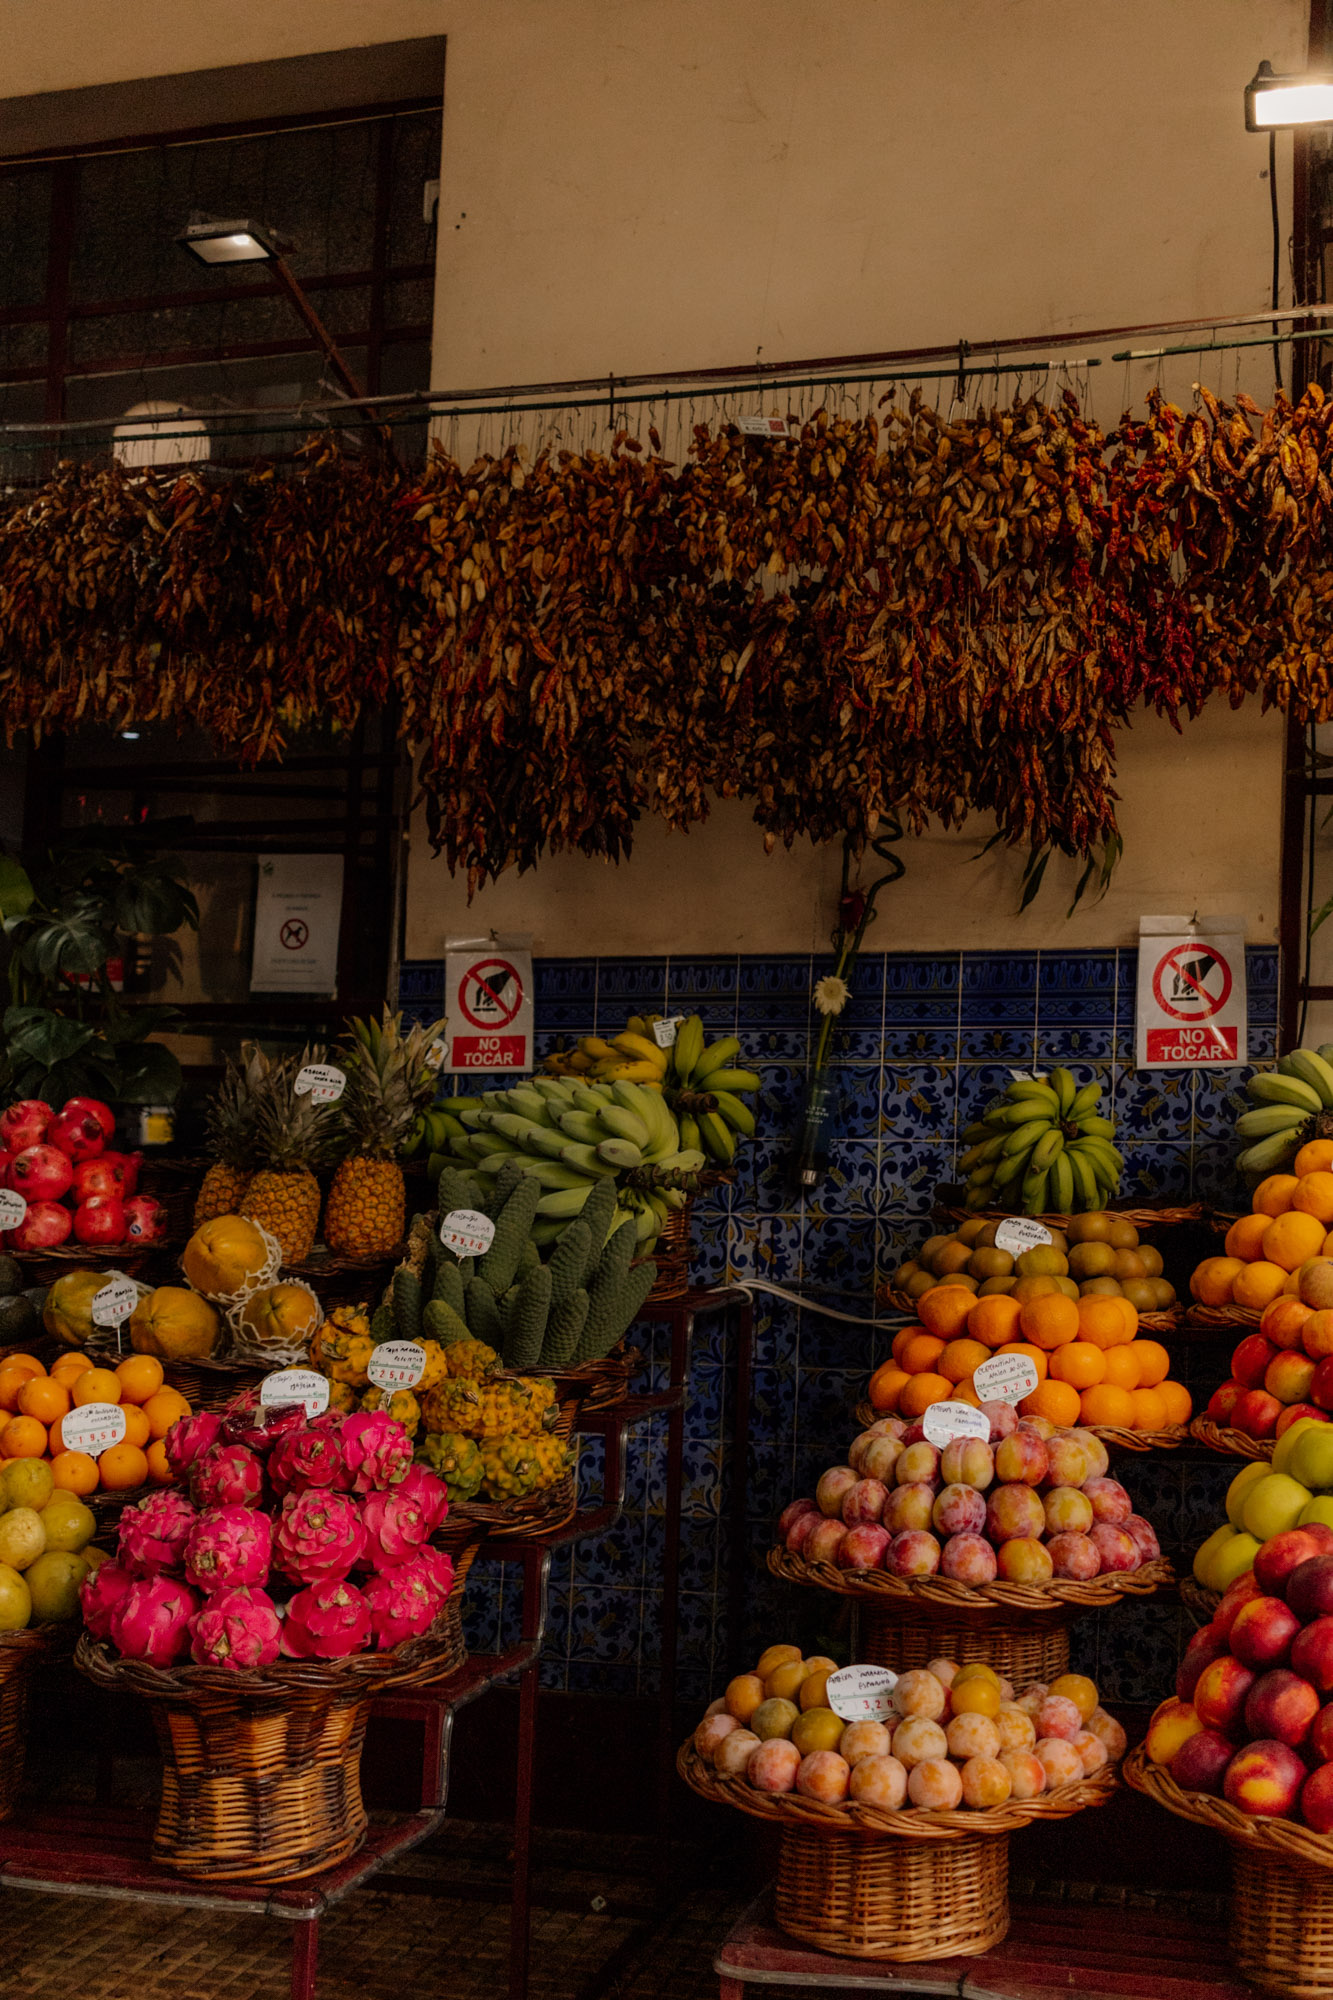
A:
[{"left": 893, "top": 1208, "right": 1175, "bottom": 1312}]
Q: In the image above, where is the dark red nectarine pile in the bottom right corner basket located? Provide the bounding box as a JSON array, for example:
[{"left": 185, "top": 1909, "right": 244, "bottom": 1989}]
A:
[{"left": 1145, "top": 1526, "right": 1333, "bottom": 1834}]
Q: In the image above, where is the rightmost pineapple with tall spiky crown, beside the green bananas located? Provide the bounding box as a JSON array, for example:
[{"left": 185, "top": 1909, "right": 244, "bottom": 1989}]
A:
[{"left": 324, "top": 1008, "right": 444, "bottom": 1258}]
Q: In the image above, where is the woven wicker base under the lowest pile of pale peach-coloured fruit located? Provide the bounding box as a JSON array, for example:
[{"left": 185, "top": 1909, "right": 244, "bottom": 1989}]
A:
[{"left": 773, "top": 1826, "right": 1009, "bottom": 1960}]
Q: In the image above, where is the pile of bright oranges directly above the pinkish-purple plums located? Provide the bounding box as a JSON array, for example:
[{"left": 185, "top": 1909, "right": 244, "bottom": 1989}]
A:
[{"left": 869, "top": 1280, "right": 1193, "bottom": 1432}]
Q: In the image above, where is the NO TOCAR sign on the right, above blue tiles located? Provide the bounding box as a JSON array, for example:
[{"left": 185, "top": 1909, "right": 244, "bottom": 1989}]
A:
[{"left": 1135, "top": 916, "right": 1249, "bottom": 1070}]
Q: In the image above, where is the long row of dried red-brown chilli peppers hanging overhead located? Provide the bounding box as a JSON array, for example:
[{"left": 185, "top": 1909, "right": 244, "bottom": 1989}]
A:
[{"left": 0, "top": 388, "right": 1333, "bottom": 882}]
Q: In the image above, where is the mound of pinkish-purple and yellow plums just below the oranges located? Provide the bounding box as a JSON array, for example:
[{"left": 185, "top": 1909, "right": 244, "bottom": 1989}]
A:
[{"left": 779, "top": 1402, "right": 1161, "bottom": 1586}]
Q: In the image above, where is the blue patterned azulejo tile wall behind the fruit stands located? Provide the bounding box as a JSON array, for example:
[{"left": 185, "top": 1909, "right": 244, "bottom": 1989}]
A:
[{"left": 400, "top": 948, "right": 1277, "bottom": 1700}]
